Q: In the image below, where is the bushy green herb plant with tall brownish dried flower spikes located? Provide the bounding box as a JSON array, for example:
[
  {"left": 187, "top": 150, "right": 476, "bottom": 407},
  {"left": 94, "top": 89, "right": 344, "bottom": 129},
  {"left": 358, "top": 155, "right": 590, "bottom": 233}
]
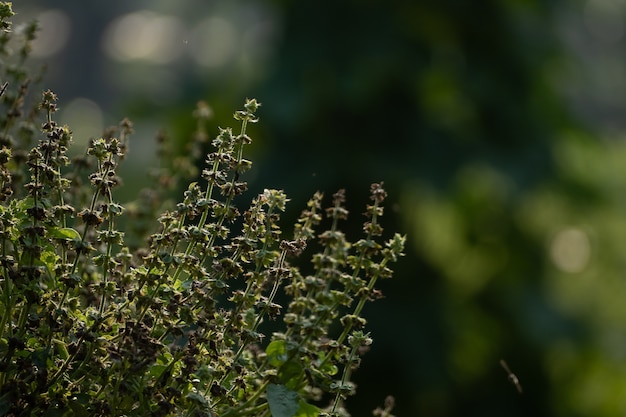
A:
[{"left": 0, "top": 3, "right": 404, "bottom": 417}]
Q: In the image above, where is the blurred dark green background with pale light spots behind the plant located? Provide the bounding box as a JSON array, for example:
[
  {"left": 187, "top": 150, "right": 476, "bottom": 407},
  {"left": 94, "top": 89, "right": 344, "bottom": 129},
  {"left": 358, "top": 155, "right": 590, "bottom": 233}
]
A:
[{"left": 14, "top": 0, "right": 626, "bottom": 417}]
